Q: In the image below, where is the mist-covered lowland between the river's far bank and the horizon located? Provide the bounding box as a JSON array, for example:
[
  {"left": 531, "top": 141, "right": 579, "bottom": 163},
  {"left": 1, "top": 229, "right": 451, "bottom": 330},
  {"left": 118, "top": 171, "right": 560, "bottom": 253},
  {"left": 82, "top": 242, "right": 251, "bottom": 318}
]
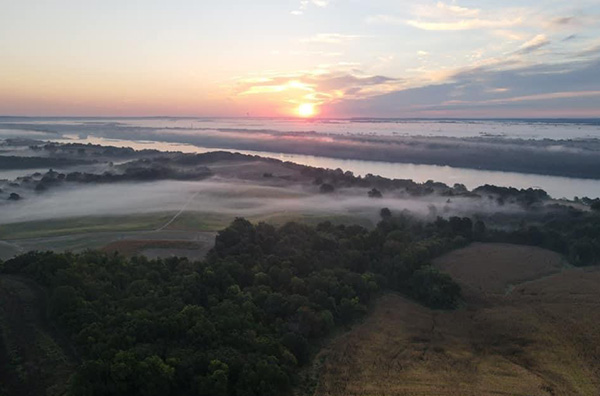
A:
[{"left": 0, "top": 119, "right": 600, "bottom": 179}]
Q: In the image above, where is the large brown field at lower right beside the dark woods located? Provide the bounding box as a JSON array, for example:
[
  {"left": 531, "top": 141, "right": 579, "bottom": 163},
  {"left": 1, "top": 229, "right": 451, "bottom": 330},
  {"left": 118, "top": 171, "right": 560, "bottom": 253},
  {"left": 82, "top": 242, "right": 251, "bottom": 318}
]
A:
[{"left": 315, "top": 244, "right": 600, "bottom": 396}]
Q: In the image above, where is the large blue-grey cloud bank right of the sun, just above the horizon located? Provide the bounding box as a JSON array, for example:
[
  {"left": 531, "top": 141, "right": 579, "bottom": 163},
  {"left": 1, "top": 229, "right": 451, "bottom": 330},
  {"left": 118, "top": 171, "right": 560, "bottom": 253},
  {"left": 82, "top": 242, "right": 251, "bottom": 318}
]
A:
[{"left": 335, "top": 57, "right": 600, "bottom": 117}]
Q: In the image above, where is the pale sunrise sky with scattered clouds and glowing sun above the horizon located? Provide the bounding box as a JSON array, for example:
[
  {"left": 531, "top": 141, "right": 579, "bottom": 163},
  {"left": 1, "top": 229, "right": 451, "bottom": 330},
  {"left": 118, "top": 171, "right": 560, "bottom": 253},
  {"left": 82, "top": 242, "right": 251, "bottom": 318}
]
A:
[{"left": 0, "top": 0, "right": 600, "bottom": 118}]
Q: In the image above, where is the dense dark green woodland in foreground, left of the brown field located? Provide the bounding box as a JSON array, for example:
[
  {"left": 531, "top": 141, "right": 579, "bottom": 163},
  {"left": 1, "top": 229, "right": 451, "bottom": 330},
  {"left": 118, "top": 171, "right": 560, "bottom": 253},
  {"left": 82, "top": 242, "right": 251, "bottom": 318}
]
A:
[{"left": 0, "top": 210, "right": 474, "bottom": 396}]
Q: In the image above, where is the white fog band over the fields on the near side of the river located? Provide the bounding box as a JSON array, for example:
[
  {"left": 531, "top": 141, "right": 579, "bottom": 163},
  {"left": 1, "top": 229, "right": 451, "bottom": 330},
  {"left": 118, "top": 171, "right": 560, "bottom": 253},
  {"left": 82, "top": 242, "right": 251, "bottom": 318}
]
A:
[{"left": 0, "top": 178, "right": 522, "bottom": 224}]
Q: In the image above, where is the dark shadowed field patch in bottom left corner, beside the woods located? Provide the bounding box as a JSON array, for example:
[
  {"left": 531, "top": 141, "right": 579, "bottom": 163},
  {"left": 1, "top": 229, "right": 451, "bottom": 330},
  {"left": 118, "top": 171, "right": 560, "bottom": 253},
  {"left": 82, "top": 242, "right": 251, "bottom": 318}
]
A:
[{"left": 0, "top": 275, "right": 77, "bottom": 396}]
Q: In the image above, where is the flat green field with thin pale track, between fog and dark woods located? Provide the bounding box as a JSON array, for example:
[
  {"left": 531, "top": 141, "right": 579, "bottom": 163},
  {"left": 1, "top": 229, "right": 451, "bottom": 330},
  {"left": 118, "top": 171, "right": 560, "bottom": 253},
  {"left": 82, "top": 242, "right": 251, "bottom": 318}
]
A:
[{"left": 0, "top": 211, "right": 372, "bottom": 260}]
